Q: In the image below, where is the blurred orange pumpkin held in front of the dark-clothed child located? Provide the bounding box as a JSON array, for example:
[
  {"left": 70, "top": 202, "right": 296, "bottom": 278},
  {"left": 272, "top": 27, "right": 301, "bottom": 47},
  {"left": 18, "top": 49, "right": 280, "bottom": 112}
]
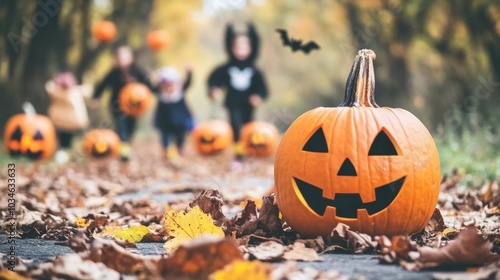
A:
[{"left": 118, "top": 83, "right": 154, "bottom": 116}]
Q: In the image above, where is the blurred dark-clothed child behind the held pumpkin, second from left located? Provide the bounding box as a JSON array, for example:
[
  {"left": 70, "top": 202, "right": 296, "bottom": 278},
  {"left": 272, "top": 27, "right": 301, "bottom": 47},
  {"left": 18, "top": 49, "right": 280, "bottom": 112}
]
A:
[{"left": 93, "top": 46, "right": 152, "bottom": 161}]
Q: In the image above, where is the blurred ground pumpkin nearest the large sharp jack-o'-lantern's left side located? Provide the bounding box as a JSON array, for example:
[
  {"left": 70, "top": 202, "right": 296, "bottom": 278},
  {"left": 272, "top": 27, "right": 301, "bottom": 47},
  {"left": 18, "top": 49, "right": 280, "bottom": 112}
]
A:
[{"left": 241, "top": 121, "right": 278, "bottom": 157}]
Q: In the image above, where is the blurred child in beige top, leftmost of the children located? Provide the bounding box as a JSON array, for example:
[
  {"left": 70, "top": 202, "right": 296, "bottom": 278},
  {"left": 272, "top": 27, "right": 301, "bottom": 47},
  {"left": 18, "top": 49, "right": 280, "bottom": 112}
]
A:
[{"left": 45, "top": 72, "right": 92, "bottom": 163}]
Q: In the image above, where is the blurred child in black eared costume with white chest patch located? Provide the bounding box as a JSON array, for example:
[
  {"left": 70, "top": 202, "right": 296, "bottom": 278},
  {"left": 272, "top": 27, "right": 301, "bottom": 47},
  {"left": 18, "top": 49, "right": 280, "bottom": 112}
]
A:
[{"left": 208, "top": 24, "right": 268, "bottom": 169}]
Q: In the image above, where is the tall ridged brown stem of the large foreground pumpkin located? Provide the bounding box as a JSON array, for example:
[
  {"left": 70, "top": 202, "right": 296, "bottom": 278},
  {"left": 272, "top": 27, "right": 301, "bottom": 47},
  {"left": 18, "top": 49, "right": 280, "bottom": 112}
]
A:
[{"left": 340, "top": 49, "right": 379, "bottom": 108}]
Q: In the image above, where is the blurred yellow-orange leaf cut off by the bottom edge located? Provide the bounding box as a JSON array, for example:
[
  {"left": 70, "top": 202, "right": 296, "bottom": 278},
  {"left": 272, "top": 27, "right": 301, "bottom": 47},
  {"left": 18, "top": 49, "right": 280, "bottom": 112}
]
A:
[{"left": 210, "top": 260, "right": 272, "bottom": 280}]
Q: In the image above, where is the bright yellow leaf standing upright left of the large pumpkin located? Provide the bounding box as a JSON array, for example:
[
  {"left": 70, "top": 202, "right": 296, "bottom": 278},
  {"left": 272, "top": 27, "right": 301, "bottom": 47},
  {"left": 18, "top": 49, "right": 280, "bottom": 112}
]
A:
[{"left": 164, "top": 206, "right": 224, "bottom": 252}]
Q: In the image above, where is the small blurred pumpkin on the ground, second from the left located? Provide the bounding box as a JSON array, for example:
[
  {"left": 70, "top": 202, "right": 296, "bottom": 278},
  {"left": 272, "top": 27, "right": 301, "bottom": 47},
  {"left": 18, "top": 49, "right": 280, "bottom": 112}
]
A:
[{"left": 83, "top": 129, "right": 121, "bottom": 158}]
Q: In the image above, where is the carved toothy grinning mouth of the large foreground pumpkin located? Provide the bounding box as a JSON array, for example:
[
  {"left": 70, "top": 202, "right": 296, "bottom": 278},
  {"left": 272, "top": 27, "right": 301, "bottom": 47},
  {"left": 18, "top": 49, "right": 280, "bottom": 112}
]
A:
[{"left": 293, "top": 176, "right": 406, "bottom": 219}]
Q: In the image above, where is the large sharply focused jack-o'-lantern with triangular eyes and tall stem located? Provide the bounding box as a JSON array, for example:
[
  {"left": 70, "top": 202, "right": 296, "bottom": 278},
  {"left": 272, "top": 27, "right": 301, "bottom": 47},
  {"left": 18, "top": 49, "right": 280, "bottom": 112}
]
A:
[{"left": 275, "top": 50, "right": 440, "bottom": 237}]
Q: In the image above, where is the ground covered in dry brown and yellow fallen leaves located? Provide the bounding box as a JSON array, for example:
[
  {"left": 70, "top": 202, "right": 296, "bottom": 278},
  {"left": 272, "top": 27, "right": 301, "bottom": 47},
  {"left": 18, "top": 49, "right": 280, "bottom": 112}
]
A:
[{"left": 0, "top": 143, "right": 500, "bottom": 279}]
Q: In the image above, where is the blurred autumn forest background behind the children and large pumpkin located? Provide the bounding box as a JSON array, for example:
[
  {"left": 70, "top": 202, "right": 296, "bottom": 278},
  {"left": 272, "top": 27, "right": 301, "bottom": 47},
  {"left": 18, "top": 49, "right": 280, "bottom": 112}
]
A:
[{"left": 0, "top": 0, "right": 500, "bottom": 178}]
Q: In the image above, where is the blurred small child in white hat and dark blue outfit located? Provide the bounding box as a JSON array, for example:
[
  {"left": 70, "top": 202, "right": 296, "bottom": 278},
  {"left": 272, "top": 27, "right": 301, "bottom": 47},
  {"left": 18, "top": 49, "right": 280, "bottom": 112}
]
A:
[{"left": 155, "top": 67, "right": 193, "bottom": 160}]
